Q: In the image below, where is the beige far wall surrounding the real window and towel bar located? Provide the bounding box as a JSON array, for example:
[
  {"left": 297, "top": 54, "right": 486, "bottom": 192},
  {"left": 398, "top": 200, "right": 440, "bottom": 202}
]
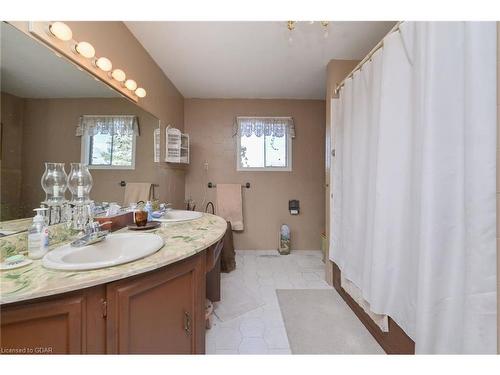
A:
[{"left": 184, "top": 99, "right": 325, "bottom": 250}]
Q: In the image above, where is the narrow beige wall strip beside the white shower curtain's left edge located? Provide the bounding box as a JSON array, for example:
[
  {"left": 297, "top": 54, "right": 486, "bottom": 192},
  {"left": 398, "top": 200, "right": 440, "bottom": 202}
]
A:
[{"left": 325, "top": 60, "right": 359, "bottom": 285}]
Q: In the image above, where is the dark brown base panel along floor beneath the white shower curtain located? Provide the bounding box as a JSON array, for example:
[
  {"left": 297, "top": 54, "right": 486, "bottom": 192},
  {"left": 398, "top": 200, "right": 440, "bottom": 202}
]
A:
[{"left": 330, "top": 261, "right": 415, "bottom": 354}]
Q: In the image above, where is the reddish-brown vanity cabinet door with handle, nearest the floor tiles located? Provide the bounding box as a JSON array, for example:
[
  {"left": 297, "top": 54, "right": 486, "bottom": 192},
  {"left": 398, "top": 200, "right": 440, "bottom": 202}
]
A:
[{"left": 106, "top": 253, "right": 205, "bottom": 354}]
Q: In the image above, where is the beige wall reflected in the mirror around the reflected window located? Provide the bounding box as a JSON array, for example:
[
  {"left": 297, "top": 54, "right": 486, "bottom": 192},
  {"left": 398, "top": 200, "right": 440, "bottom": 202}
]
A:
[{"left": 22, "top": 98, "right": 172, "bottom": 216}]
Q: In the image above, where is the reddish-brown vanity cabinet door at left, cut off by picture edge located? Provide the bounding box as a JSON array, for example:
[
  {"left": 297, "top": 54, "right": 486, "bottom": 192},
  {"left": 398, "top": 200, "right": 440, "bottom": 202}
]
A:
[{"left": 0, "top": 287, "right": 105, "bottom": 354}]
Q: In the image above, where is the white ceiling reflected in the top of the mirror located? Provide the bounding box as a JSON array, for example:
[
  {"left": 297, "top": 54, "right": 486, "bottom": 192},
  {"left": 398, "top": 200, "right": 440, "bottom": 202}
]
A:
[{"left": 0, "top": 22, "right": 121, "bottom": 99}]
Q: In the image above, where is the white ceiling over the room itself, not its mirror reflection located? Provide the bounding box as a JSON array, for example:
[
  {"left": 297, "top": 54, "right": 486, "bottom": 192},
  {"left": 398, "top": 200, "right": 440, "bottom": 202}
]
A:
[{"left": 125, "top": 22, "right": 394, "bottom": 99}]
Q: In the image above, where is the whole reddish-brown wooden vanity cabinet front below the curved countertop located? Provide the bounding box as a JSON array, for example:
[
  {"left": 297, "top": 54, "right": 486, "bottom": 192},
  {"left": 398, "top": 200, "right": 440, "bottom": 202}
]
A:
[{"left": 0, "top": 251, "right": 206, "bottom": 354}]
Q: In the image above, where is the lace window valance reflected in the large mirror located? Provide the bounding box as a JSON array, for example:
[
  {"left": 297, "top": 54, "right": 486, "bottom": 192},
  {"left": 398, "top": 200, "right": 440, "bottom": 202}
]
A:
[{"left": 76, "top": 115, "right": 139, "bottom": 136}]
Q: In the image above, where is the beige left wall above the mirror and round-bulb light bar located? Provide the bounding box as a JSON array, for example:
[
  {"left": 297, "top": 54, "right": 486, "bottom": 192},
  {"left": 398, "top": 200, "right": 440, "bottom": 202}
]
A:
[{"left": 11, "top": 21, "right": 185, "bottom": 208}]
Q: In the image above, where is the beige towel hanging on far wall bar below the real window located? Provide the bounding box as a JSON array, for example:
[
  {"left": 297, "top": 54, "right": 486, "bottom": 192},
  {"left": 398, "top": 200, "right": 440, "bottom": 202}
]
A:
[{"left": 217, "top": 184, "right": 243, "bottom": 231}]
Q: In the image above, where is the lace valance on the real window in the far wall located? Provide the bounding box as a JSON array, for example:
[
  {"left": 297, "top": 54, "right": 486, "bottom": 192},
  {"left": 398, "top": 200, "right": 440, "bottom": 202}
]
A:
[{"left": 236, "top": 117, "right": 295, "bottom": 138}]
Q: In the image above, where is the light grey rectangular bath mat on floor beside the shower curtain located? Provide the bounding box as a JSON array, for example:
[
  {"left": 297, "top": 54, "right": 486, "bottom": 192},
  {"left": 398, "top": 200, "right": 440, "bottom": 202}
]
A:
[{"left": 276, "top": 289, "right": 384, "bottom": 354}]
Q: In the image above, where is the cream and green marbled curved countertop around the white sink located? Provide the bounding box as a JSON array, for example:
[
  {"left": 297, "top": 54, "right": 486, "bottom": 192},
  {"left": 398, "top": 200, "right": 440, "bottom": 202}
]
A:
[{"left": 0, "top": 214, "right": 227, "bottom": 304}]
